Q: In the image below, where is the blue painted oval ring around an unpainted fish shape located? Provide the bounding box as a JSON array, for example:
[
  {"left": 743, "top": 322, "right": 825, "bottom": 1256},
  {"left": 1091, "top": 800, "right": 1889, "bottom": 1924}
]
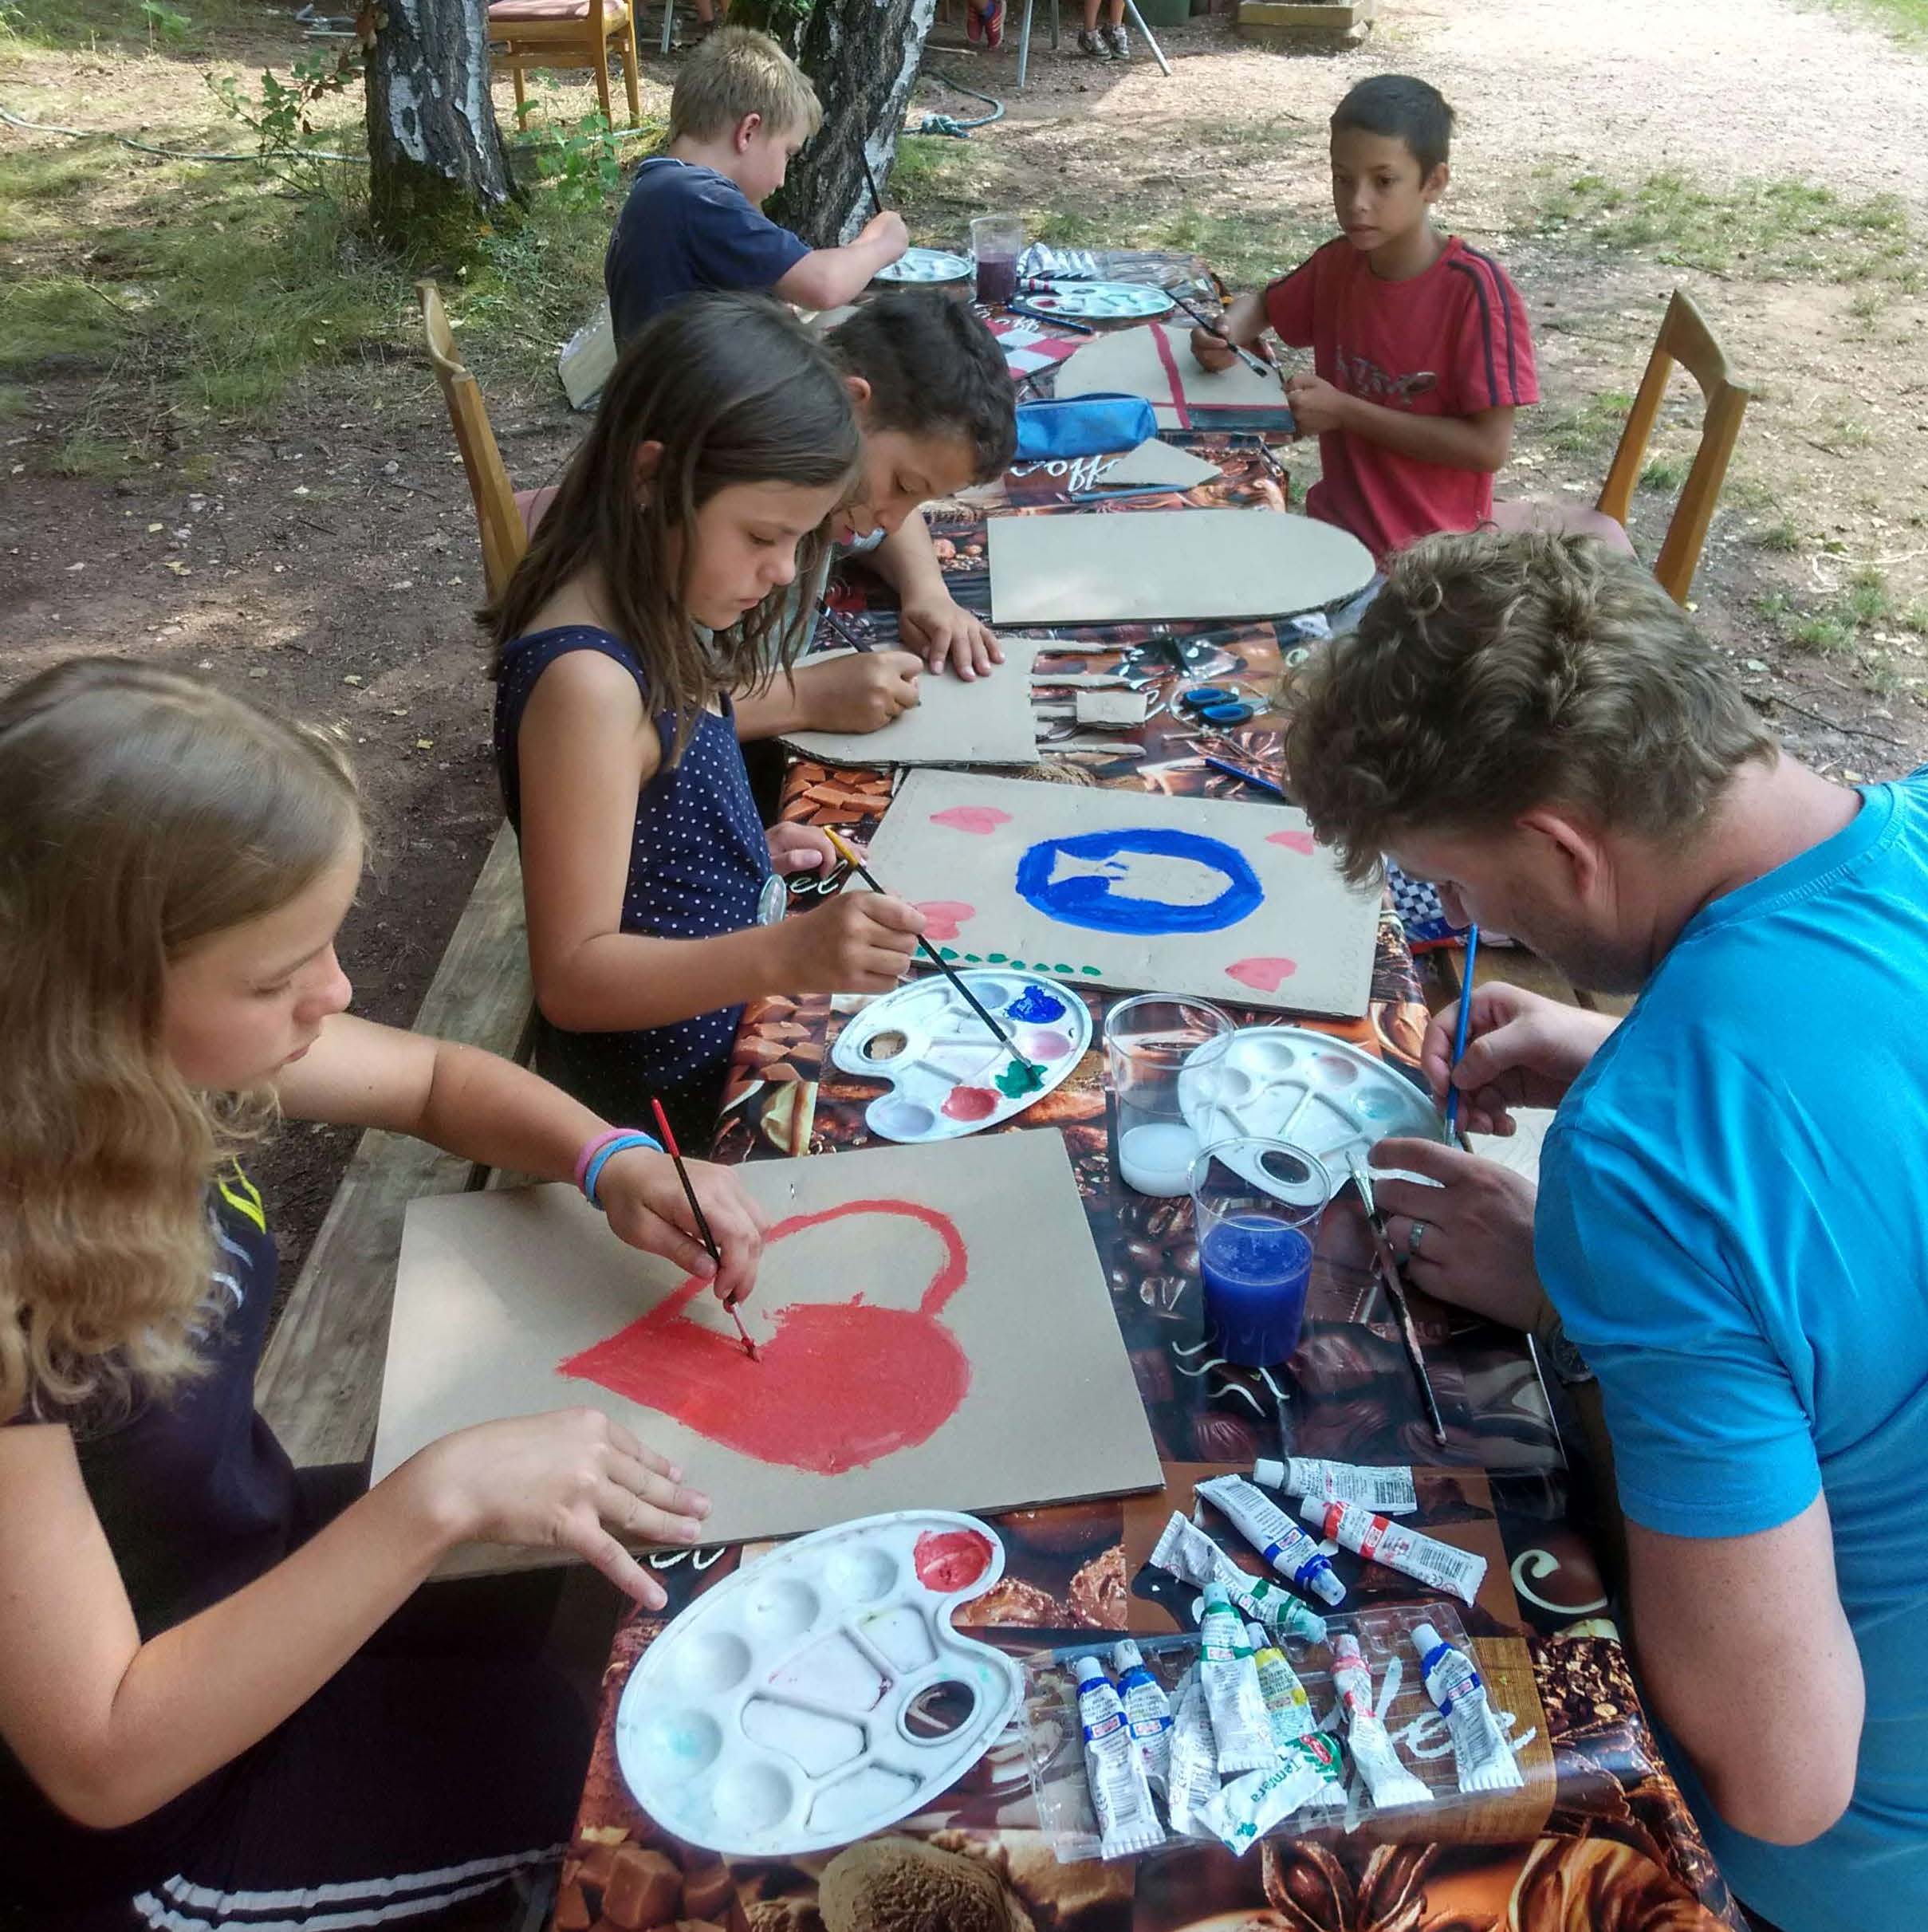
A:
[{"left": 1016, "top": 828, "right": 1265, "bottom": 937}]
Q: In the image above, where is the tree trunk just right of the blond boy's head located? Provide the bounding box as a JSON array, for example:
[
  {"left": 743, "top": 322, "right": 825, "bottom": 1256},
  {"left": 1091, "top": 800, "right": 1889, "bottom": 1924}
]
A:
[{"left": 767, "top": 0, "right": 937, "bottom": 247}]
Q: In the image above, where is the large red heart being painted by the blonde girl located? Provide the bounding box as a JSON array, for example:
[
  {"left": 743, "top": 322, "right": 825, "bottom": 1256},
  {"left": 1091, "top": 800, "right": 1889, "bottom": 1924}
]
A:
[{"left": 558, "top": 1200, "right": 970, "bottom": 1476}]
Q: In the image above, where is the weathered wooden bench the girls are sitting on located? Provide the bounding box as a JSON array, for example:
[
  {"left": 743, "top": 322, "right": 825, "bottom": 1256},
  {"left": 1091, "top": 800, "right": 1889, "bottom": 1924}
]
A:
[{"left": 255, "top": 825, "right": 535, "bottom": 1466}]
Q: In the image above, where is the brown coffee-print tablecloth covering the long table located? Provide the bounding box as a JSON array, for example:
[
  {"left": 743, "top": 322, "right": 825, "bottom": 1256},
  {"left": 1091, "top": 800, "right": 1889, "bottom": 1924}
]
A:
[{"left": 557, "top": 415, "right": 1742, "bottom": 1932}]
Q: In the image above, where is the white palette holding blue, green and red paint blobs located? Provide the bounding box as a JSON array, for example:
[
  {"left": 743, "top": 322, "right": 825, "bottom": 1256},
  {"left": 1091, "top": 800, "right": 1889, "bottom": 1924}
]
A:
[{"left": 831, "top": 968, "right": 1092, "bottom": 1143}]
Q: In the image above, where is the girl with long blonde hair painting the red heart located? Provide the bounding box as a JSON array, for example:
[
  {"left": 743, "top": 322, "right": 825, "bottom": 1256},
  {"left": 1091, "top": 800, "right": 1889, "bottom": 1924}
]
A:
[{"left": 0, "top": 659, "right": 761, "bottom": 1932}]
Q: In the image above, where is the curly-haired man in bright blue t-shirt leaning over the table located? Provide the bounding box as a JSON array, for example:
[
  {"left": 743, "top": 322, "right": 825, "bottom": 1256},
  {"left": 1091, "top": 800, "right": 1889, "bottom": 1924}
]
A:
[{"left": 1285, "top": 533, "right": 1928, "bottom": 1932}]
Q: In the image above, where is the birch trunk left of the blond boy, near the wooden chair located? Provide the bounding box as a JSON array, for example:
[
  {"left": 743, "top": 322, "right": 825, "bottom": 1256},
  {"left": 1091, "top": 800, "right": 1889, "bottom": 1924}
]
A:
[{"left": 369, "top": 0, "right": 516, "bottom": 261}]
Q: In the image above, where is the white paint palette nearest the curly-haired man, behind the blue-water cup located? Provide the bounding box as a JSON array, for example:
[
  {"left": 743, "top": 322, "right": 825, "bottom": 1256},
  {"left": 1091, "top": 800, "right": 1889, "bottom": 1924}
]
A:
[{"left": 1184, "top": 1026, "right": 1445, "bottom": 1188}]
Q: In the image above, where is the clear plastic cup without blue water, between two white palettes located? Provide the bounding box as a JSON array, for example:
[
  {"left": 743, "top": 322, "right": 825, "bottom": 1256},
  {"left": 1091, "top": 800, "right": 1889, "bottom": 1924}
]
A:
[{"left": 1105, "top": 993, "right": 1233, "bottom": 1196}]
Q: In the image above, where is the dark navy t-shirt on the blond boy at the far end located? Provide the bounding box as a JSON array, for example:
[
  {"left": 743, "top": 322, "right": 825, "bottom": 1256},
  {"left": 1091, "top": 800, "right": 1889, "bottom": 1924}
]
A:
[{"left": 603, "top": 155, "right": 809, "bottom": 350}]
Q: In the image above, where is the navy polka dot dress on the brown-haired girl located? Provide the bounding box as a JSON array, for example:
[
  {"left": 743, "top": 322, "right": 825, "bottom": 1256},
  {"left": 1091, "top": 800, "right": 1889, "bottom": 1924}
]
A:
[{"left": 494, "top": 624, "right": 771, "bottom": 1146}]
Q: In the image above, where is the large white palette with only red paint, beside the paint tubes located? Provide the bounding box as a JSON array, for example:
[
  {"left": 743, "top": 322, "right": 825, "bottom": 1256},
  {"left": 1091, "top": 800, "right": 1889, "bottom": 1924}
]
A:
[{"left": 616, "top": 1509, "right": 1022, "bottom": 1859}]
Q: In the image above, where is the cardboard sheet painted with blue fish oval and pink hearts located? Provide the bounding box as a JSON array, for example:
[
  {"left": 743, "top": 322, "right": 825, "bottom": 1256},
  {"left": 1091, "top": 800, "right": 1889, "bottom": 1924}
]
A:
[{"left": 869, "top": 769, "right": 1379, "bottom": 1018}]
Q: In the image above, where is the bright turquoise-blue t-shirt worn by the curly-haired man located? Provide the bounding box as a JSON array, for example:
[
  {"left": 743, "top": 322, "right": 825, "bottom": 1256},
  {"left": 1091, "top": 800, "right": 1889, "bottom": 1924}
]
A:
[{"left": 1536, "top": 773, "right": 1928, "bottom": 1932}]
